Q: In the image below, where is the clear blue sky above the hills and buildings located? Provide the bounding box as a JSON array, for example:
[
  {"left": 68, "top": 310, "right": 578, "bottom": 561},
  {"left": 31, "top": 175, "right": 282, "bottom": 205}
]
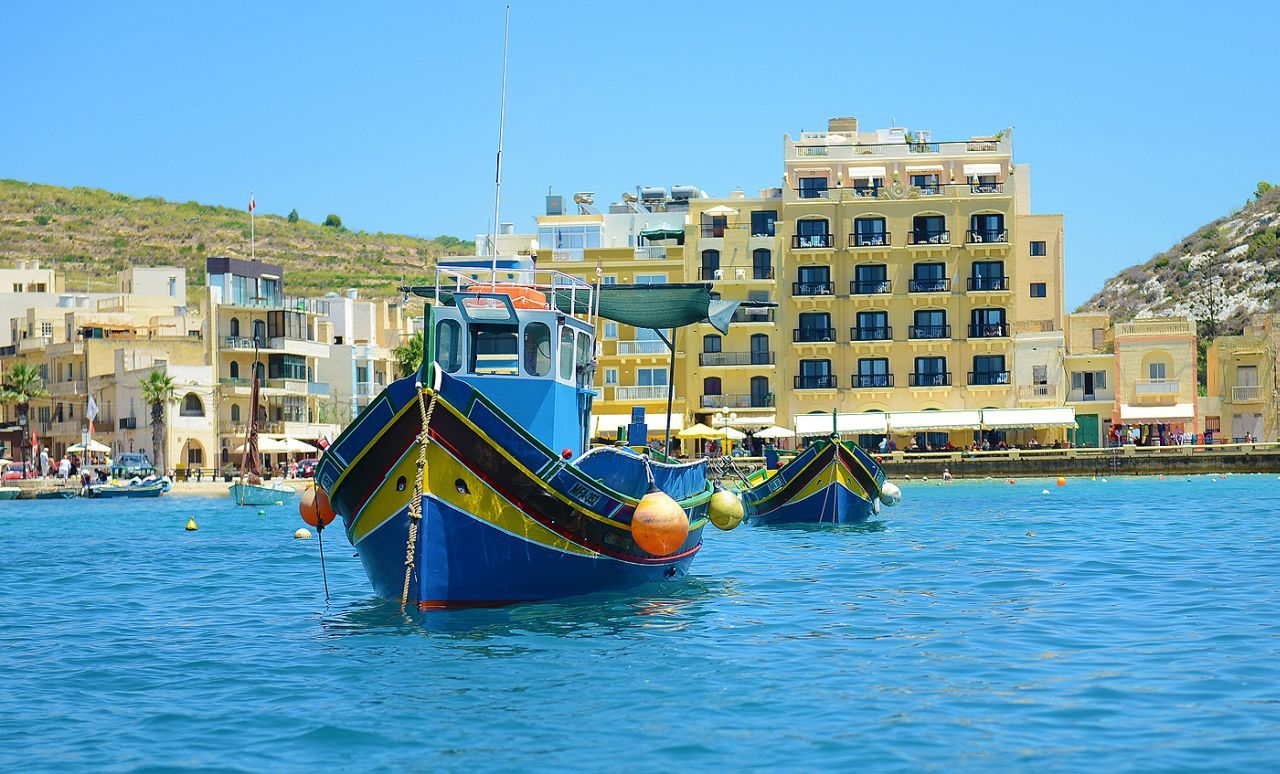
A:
[{"left": 0, "top": 1, "right": 1280, "bottom": 307}]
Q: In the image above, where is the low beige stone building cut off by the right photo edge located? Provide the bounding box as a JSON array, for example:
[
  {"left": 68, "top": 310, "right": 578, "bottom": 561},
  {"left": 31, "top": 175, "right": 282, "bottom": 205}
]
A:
[{"left": 1201, "top": 315, "right": 1280, "bottom": 443}]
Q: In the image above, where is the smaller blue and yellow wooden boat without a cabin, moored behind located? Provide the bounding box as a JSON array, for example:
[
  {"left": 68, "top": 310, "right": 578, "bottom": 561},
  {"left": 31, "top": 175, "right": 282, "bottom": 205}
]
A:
[{"left": 733, "top": 436, "right": 901, "bottom": 526}]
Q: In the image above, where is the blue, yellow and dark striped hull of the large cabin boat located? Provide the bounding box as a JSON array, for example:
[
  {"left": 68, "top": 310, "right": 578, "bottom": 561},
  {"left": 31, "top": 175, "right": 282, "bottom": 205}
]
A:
[{"left": 316, "top": 371, "right": 712, "bottom": 609}]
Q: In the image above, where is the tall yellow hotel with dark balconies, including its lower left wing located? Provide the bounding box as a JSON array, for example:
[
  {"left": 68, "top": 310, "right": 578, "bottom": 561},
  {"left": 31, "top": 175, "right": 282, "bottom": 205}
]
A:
[{"left": 516, "top": 112, "right": 1066, "bottom": 445}]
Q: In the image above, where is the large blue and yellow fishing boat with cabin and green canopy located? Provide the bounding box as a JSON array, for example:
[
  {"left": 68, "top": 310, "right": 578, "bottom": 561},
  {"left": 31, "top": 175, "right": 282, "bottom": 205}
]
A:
[{"left": 315, "top": 260, "right": 740, "bottom": 609}]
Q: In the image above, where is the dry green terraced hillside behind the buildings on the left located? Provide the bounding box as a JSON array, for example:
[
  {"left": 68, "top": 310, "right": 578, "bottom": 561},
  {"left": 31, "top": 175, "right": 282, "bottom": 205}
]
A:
[{"left": 0, "top": 179, "right": 475, "bottom": 297}]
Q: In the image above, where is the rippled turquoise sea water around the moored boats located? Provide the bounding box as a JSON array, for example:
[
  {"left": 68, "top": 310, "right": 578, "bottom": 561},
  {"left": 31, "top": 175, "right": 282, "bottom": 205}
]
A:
[{"left": 0, "top": 476, "right": 1280, "bottom": 770}]
